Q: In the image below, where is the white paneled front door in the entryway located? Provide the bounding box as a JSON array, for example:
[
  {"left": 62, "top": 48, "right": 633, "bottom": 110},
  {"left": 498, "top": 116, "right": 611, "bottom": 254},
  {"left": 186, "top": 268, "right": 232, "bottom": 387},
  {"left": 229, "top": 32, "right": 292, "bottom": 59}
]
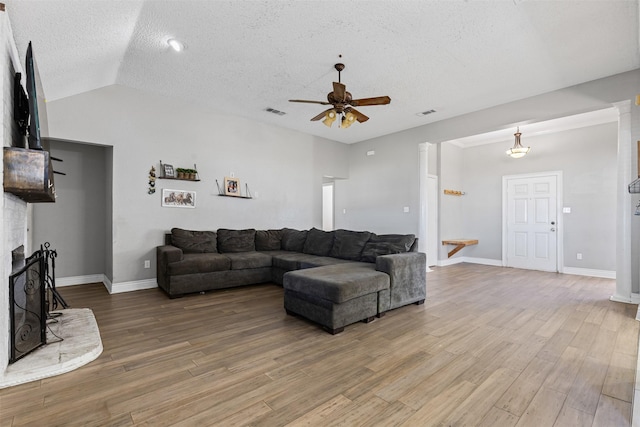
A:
[{"left": 506, "top": 175, "right": 558, "bottom": 271}]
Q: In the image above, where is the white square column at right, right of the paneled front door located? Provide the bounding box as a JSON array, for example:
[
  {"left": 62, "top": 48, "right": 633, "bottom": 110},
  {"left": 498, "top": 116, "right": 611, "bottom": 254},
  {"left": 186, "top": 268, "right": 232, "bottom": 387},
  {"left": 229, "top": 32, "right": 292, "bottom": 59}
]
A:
[{"left": 610, "top": 100, "right": 640, "bottom": 304}]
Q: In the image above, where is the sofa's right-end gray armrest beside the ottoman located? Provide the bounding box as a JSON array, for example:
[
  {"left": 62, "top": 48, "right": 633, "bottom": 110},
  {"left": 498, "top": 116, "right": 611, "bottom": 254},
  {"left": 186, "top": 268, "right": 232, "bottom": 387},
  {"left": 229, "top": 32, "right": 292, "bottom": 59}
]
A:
[{"left": 376, "top": 252, "right": 427, "bottom": 310}]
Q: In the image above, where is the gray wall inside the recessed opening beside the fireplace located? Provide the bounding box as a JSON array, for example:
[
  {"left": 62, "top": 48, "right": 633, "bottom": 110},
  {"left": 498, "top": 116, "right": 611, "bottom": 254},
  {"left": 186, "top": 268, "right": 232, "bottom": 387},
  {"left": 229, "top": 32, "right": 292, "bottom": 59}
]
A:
[{"left": 33, "top": 140, "right": 111, "bottom": 277}]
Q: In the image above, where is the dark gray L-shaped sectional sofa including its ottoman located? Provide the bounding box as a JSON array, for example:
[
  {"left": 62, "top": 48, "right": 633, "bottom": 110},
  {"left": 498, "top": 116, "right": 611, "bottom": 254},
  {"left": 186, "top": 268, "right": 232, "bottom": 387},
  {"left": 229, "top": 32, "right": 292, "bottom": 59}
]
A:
[{"left": 156, "top": 228, "right": 426, "bottom": 334}]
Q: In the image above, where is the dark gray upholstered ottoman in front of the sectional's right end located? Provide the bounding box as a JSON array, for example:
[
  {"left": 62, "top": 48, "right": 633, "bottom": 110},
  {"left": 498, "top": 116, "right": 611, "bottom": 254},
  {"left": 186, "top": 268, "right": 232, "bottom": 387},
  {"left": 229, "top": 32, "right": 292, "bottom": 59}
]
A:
[{"left": 283, "top": 263, "right": 389, "bottom": 334}]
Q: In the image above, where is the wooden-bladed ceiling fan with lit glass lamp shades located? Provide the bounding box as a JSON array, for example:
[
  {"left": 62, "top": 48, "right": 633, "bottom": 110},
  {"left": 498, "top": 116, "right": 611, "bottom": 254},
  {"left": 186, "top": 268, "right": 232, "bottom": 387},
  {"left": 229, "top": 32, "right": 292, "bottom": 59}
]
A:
[{"left": 289, "top": 64, "right": 391, "bottom": 128}]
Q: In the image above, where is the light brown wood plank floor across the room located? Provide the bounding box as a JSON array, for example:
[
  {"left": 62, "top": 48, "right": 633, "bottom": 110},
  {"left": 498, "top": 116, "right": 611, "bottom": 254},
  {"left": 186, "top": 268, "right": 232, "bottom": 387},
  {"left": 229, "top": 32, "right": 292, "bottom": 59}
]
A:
[{"left": 0, "top": 264, "right": 639, "bottom": 427}]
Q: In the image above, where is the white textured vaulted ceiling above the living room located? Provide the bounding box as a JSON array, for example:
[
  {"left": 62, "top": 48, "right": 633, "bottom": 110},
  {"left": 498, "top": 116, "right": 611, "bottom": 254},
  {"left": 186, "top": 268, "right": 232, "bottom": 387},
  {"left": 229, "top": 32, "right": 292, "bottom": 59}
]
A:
[{"left": 5, "top": 0, "right": 640, "bottom": 143}]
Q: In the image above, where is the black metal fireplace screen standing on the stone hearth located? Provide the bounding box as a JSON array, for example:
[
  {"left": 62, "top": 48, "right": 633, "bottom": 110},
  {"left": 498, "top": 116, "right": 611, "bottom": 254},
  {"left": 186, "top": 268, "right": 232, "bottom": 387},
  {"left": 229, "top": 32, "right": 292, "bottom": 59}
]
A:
[{"left": 9, "top": 251, "right": 47, "bottom": 363}]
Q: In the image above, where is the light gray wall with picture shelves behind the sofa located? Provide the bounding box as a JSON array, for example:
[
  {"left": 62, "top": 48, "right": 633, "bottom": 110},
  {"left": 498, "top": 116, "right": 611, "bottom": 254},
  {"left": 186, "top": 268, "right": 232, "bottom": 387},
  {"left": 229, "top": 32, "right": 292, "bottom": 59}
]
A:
[{"left": 48, "top": 85, "right": 348, "bottom": 284}]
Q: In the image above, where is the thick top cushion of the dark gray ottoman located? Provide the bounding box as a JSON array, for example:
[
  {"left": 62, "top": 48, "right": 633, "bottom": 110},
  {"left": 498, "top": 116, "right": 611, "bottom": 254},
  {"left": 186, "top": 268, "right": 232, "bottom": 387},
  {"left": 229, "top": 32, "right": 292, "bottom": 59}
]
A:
[{"left": 283, "top": 264, "right": 389, "bottom": 304}]
